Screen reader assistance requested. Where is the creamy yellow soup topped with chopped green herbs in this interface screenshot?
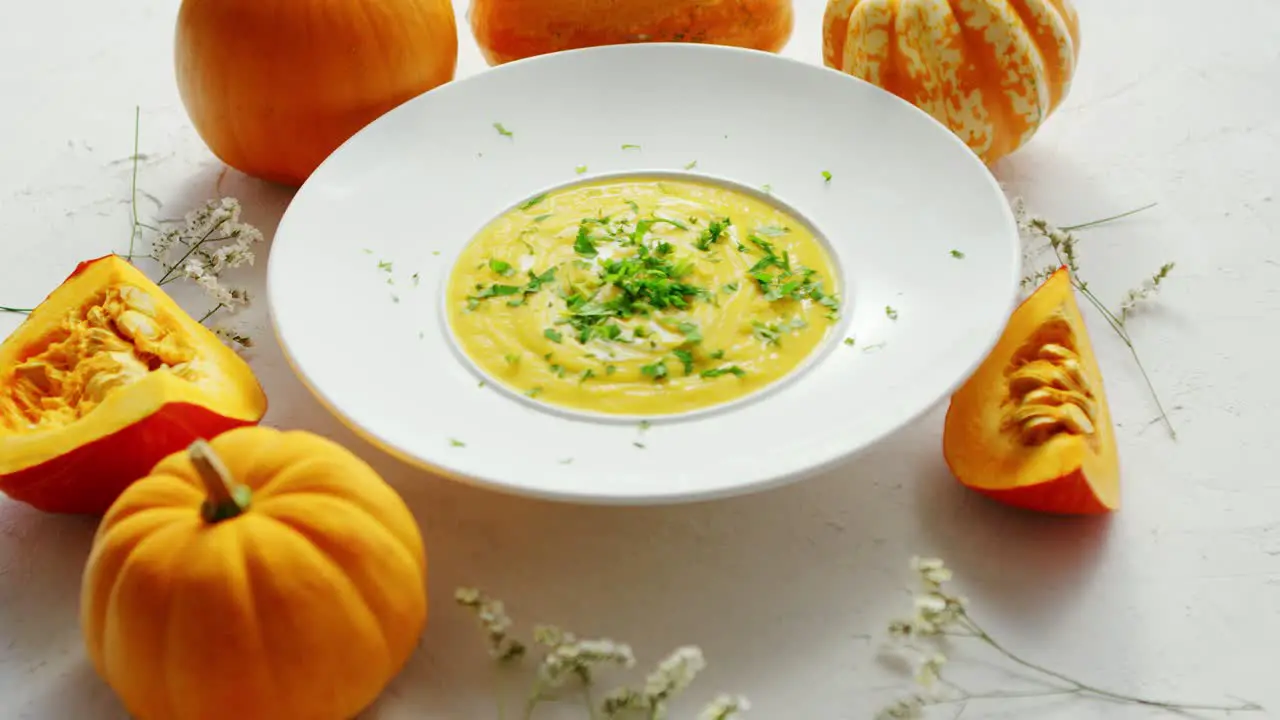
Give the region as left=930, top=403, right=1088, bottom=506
left=447, top=177, right=840, bottom=416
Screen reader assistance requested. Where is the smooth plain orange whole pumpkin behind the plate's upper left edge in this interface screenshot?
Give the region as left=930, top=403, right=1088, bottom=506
left=174, top=0, right=458, bottom=186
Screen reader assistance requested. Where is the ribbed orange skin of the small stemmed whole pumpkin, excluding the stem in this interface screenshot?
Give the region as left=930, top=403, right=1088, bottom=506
left=81, top=427, right=426, bottom=720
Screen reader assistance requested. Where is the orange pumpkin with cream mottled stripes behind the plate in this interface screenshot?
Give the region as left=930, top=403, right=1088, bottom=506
left=822, top=0, right=1080, bottom=164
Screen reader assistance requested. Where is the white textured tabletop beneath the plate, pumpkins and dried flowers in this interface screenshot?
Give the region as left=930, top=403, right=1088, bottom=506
left=0, top=0, right=1280, bottom=720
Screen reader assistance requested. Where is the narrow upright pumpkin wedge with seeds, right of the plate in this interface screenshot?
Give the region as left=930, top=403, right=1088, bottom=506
left=942, top=268, right=1120, bottom=515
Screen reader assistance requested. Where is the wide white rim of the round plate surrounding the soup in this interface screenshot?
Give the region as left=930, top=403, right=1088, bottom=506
left=268, top=45, right=1020, bottom=503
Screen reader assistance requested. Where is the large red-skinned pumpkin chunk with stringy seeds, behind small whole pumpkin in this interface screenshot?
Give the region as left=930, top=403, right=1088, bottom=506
left=0, top=255, right=266, bottom=515
